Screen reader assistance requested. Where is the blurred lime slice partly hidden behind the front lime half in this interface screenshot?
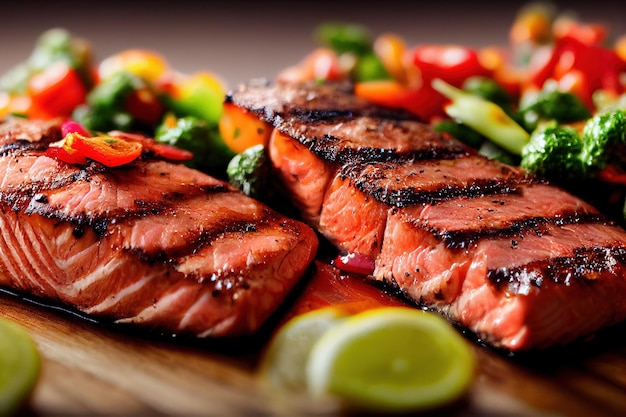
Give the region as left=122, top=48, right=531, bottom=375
left=259, top=307, right=347, bottom=392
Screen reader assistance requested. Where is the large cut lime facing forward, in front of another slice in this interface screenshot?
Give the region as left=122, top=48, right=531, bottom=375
left=306, top=307, right=475, bottom=412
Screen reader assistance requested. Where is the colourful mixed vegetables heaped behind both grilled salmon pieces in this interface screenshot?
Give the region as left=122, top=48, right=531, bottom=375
left=0, top=3, right=626, bottom=221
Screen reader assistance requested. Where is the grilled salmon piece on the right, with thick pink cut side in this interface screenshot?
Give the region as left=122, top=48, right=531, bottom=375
left=227, top=79, right=626, bottom=351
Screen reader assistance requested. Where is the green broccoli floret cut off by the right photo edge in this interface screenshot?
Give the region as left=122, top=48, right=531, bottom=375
left=580, top=109, right=626, bottom=170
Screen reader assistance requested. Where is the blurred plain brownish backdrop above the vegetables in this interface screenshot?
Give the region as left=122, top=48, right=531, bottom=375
left=0, top=0, right=626, bottom=86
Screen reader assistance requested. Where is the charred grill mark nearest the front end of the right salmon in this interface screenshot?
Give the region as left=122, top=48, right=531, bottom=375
left=487, top=247, right=626, bottom=290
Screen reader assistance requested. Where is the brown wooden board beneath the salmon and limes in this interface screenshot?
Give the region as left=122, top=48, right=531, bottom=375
left=0, top=264, right=626, bottom=417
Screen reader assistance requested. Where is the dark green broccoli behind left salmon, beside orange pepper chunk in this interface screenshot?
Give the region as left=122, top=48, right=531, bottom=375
left=154, top=116, right=235, bottom=176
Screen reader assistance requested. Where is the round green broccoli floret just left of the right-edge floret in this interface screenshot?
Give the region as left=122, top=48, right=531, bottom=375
left=520, top=123, right=584, bottom=180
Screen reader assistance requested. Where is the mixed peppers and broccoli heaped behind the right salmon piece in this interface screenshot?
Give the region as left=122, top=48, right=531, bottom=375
left=278, top=3, right=626, bottom=223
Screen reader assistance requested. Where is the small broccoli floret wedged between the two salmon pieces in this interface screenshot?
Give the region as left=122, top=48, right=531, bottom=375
left=226, top=145, right=268, bottom=198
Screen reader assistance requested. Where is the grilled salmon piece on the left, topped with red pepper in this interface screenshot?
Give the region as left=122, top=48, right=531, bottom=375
left=0, top=118, right=318, bottom=338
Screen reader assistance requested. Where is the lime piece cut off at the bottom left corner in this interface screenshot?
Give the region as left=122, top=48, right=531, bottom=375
left=0, top=317, right=41, bottom=416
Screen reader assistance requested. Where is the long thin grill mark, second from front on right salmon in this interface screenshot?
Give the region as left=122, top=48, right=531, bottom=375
left=436, top=213, right=607, bottom=249
